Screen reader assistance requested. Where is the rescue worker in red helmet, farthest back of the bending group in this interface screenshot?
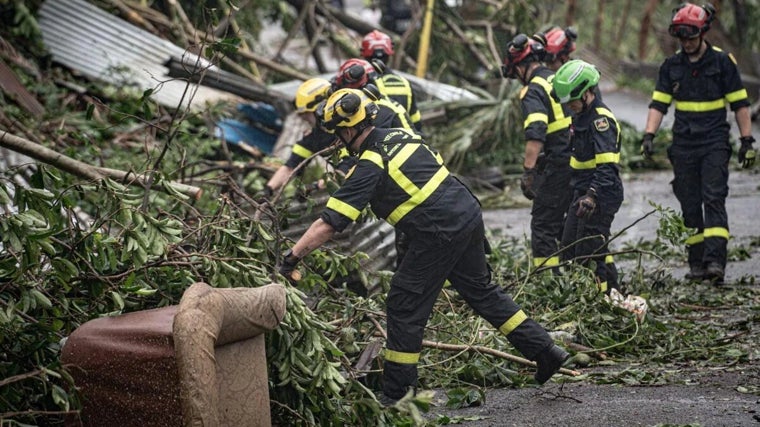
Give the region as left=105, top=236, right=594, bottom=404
left=361, top=30, right=422, bottom=131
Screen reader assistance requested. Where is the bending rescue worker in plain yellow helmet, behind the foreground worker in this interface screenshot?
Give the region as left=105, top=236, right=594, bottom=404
left=263, top=78, right=356, bottom=198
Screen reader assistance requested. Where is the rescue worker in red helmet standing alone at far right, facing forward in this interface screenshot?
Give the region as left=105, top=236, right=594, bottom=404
left=641, top=3, right=756, bottom=284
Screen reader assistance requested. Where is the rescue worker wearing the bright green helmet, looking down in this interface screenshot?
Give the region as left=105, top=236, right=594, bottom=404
left=552, top=59, right=623, bottom=294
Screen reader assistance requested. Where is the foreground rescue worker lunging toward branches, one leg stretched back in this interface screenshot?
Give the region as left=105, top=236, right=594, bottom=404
left=279, top=89, right=568, bottom=404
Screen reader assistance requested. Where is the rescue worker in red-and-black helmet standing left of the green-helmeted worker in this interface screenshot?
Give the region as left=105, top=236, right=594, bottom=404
left=502, top=34, right=572, bottom=274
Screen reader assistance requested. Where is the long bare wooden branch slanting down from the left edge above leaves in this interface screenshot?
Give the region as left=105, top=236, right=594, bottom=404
left=0, top=132, right=203, bottom=199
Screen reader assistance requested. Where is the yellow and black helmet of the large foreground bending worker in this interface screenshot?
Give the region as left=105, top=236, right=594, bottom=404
left=321, top=88, right=379, bottom=131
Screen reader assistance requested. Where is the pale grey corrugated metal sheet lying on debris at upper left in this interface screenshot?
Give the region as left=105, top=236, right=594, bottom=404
left=39, top=0, right=240, bottom=107
